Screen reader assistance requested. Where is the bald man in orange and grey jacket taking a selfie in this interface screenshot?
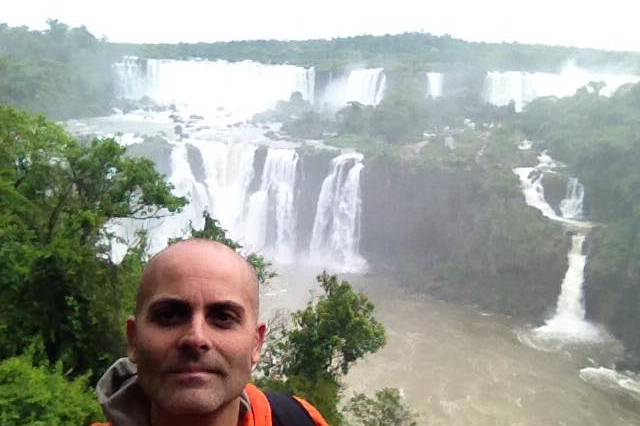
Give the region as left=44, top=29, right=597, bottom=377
left=97, top=240, right=327, bottom=426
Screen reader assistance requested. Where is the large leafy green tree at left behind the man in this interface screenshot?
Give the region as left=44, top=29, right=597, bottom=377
left=0, top=106, right=185, bottom=380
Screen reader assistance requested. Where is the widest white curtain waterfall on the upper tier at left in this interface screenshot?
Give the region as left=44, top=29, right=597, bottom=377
left=114, top=58, right=315, bottom=120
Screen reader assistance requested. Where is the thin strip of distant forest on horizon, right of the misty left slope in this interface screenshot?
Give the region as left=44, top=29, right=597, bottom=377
left=114, top=33, right=640, bottom=72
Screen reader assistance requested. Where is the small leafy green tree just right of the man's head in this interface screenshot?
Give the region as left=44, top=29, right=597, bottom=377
left=260, top=272, right=386, bottom=424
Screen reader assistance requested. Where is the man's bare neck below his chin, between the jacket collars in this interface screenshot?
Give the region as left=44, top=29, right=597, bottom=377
left=151, top=398, right=240, bottom=426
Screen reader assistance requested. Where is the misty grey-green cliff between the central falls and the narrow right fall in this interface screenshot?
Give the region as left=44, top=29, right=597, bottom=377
left=361, top=161, right=568, bottom=322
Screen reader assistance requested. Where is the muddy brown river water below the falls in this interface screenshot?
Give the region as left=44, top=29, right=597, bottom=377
left=263, top=274, right=640, bottom=426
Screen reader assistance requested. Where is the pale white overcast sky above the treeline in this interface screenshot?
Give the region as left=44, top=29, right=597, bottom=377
left=5, top=0, right=640, bottom=51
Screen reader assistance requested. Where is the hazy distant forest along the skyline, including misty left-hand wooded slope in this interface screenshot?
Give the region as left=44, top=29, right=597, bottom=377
left=0, top=20, right=640, bottom=119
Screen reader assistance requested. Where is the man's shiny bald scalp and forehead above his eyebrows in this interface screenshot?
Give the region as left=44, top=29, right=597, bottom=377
left=136, top=239, right=259, bottom=318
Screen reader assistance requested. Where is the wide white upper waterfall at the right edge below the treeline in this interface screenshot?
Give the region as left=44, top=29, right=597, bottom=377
left=482, top=64, right=640, bottom=111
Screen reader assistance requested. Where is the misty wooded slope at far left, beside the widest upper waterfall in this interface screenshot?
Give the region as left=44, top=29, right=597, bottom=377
left=0, top=20, right=115, bottom=119
